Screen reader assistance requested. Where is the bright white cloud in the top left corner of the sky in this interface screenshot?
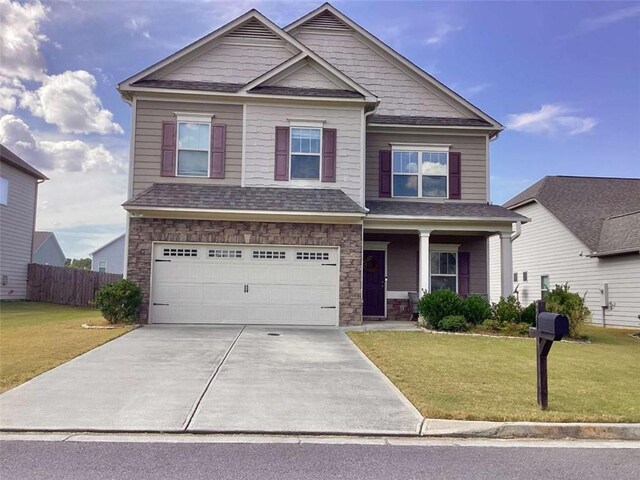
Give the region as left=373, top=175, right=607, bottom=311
left=0, top=0, right=49, bottom=80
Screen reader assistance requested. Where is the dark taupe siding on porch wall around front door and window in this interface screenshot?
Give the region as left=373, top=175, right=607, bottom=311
left=364, top=232, right=488, bottom=295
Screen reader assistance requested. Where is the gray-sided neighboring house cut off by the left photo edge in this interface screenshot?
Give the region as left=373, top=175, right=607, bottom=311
left=0, top=145, right=47, bottom=300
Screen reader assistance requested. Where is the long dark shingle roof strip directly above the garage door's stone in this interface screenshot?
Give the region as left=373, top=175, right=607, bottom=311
left=123, top=183, right=364, bottom=213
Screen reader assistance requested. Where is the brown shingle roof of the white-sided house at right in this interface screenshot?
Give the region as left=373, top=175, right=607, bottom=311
left=504, top=176, right=640, bottom=252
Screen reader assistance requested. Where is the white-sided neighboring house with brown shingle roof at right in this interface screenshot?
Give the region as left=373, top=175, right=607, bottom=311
left=491, top=176, right=640, bottom=327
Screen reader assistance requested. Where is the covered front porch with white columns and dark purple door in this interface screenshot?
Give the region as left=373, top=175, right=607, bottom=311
left=362, top=219, right=524, bottom=321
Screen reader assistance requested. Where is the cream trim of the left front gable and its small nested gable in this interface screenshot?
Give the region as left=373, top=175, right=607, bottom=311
left=118, top=9, right=377, bottom=102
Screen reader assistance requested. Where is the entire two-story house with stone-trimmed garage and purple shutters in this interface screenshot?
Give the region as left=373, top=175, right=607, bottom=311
left=118, top=4, right=527, bottom=325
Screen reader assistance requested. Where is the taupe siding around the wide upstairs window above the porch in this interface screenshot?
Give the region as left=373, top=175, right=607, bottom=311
left=365, top=130, right=487, bottom=203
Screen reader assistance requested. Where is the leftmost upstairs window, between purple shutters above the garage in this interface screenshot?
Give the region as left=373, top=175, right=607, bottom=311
left=176, top=121, right=211, bottom=177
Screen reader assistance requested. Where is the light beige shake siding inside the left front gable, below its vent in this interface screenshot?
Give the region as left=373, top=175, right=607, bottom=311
left=152, top=39, right=294, bottom=83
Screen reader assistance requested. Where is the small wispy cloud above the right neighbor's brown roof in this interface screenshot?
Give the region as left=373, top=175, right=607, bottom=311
left=506, top=104, right=598, bottom=135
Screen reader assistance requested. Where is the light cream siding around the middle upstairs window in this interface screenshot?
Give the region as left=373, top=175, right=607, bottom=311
left=245, top=105, right=362, bottom=203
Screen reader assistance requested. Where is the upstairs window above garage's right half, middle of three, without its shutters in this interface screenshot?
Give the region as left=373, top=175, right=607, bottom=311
left=289, top=127, right=322, bottom=180
